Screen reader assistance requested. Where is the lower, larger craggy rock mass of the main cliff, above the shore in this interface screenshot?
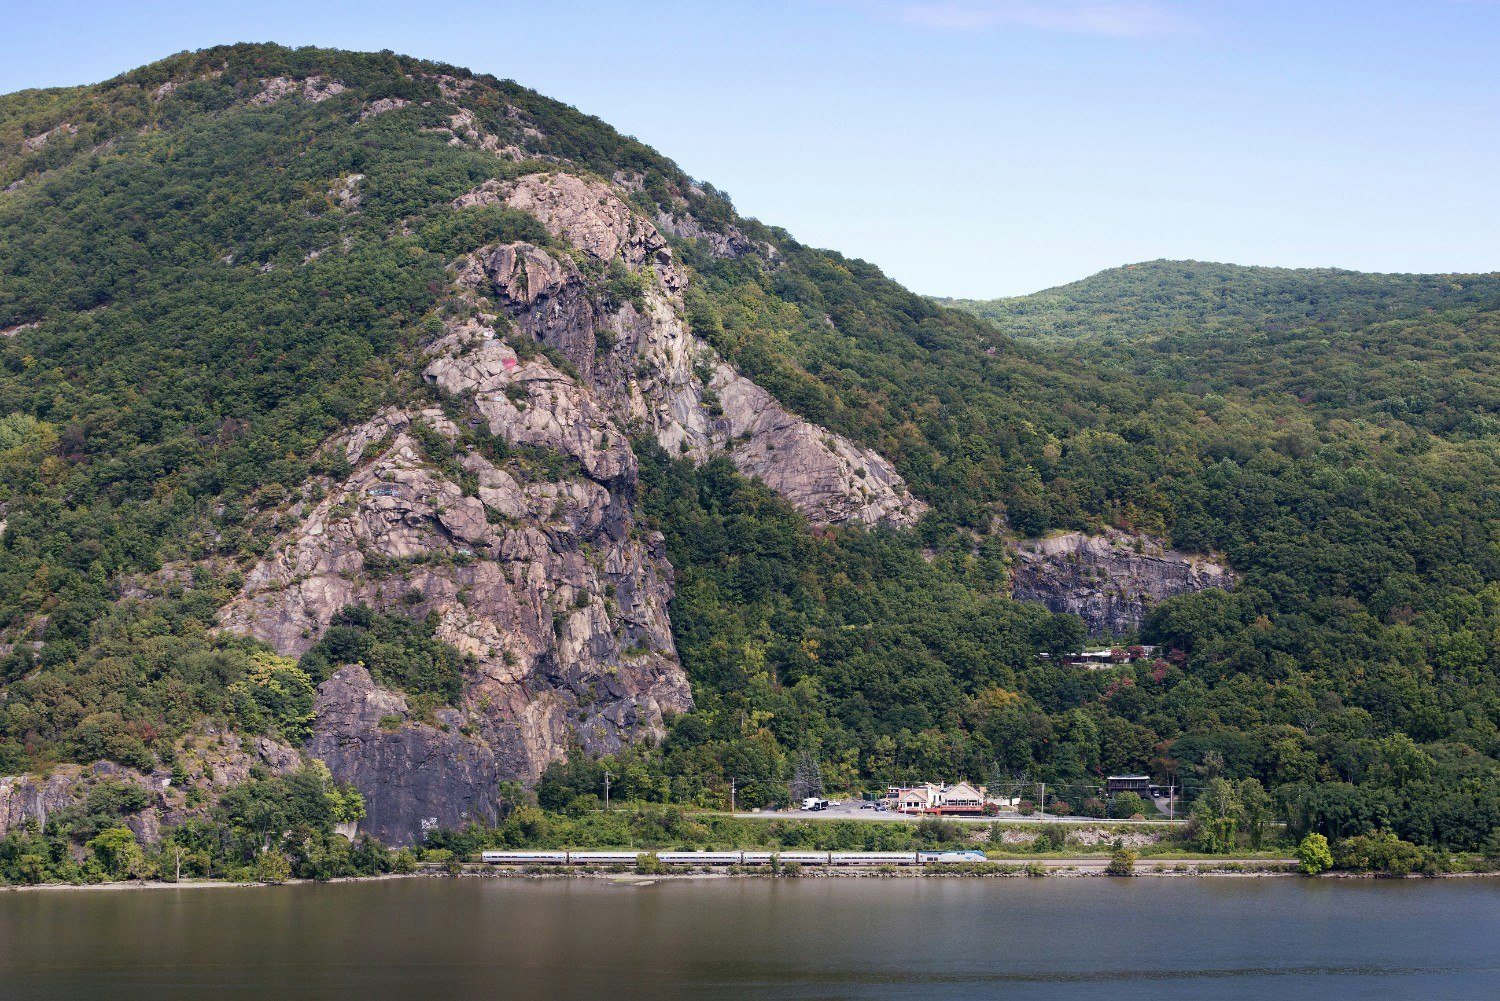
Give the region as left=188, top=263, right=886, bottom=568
left=222, top=402, right=692, bottom=843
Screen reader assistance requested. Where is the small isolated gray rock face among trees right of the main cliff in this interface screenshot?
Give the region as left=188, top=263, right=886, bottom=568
left=1011, top=531, right=1235, bottom=638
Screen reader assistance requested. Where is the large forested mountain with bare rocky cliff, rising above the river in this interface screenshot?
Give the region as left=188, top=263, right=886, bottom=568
left=0, top=45, right=1500, bottom=878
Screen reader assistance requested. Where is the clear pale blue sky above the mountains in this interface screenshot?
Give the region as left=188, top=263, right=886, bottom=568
left=0, top=0, right=1500, bottom=297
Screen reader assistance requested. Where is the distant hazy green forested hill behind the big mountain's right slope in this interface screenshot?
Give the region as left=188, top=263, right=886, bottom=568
left=950, top=261, right=1500, bottom=437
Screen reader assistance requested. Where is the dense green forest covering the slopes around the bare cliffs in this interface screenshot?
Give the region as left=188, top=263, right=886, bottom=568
left=0, top=45, right=1500, bottom=882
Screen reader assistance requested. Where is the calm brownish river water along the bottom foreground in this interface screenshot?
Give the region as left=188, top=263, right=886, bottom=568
left=0, top=876, right=1500, bottom=1001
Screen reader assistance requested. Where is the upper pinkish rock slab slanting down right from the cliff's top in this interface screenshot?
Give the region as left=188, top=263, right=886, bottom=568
left=444, top=174, right=926, bottom=525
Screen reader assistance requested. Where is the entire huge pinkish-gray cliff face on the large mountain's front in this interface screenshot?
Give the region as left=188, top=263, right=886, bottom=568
left=207, top=108, right=926, bottom=843
